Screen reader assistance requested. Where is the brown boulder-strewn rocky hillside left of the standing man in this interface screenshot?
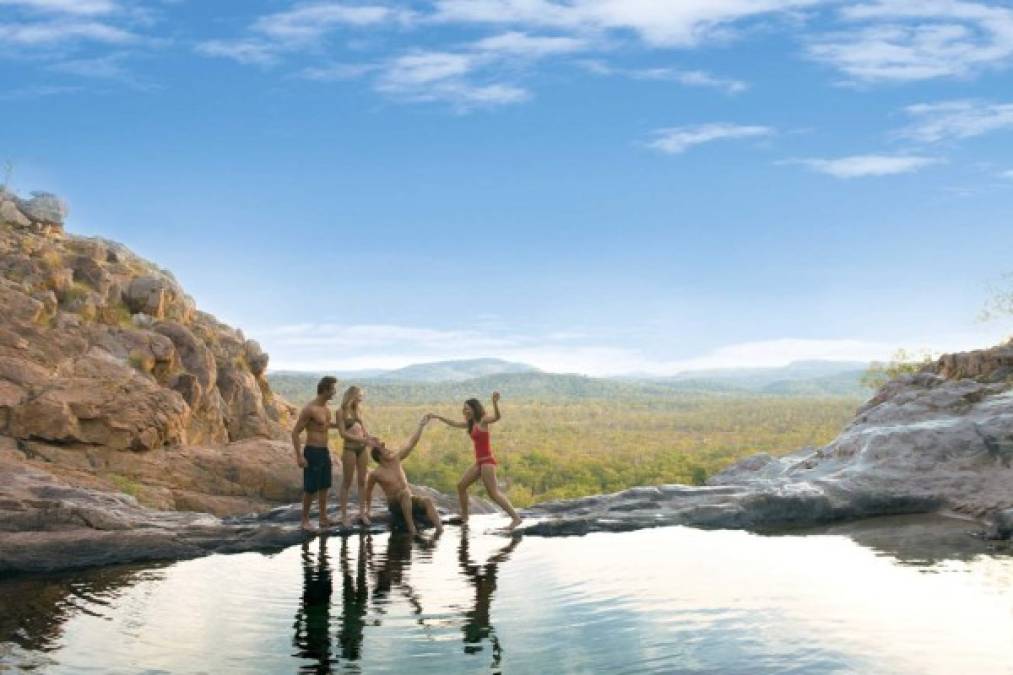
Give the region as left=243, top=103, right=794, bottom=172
left=0, top=191, right=299, bottom=514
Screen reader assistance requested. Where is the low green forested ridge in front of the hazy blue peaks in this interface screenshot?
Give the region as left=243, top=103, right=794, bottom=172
left=268, top=364, right=869, bottom=403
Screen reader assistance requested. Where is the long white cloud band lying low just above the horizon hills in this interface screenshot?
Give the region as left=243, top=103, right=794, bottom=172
left=254, top=323, right=1005, bottom=376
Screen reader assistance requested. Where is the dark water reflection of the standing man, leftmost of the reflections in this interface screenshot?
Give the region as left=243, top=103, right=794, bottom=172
left=293, top=537, right=335, bottom=673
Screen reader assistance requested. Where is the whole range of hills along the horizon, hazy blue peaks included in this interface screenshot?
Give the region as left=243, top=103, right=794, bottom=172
left=268, top=359, right=871, bottom=402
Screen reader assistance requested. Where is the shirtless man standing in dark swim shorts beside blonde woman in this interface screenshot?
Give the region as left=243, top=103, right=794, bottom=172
left=292, top=375, right=337, bottom=532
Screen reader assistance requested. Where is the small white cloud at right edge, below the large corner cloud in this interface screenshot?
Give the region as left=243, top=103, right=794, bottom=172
left=901, top=100, right=1013, bottom=143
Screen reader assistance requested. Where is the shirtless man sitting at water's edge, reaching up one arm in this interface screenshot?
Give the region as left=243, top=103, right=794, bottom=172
left=362, top=415, right=443, bottom=534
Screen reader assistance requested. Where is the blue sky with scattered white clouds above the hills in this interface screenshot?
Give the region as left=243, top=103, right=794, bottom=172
left=0, top=0, right=1013, bottom=375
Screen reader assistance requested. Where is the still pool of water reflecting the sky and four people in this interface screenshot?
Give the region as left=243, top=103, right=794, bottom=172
left=0, top=517, right=1013, bottom=674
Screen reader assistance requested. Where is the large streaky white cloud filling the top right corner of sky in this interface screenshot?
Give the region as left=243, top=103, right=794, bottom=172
left=808, top=0, right=1013, bottom=82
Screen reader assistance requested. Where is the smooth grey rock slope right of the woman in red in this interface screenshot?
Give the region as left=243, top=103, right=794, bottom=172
left=525, top=342, right=1013, bottom=539
